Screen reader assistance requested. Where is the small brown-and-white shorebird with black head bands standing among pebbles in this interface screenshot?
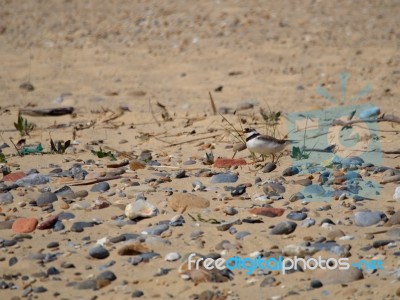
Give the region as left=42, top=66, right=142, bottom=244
left=243, top=128, right=292, bottom=162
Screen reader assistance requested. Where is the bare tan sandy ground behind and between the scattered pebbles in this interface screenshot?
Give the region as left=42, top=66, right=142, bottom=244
left=0, top=0, right=400, bottom=299
